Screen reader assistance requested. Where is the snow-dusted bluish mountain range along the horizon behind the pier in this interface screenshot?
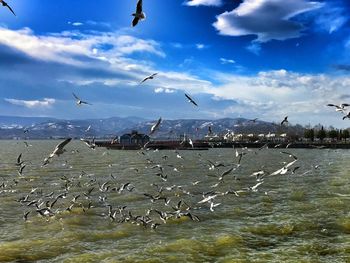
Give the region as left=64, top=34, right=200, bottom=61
left=0, top=116, right=304, bottom=139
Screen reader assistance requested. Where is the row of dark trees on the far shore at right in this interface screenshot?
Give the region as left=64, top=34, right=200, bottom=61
left=304, top=127, right=350, bottom=141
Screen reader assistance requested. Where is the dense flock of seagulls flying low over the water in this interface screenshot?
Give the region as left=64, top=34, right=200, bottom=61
left=0, top=136, right=318, bottom=229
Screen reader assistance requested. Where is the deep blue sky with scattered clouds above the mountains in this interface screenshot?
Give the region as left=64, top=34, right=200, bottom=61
left=0, top=0, right=350, bottom=128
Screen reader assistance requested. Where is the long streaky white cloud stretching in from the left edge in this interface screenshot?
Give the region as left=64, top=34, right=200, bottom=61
left=0, top=27, right=165, bottom=66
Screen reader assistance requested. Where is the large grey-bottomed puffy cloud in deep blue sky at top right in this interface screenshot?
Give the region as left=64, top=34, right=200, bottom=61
left=213, top=0, right=322, bottom=42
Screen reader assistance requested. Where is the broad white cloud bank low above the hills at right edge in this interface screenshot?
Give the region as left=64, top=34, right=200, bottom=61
left=198, top=69, right=350, bottom=125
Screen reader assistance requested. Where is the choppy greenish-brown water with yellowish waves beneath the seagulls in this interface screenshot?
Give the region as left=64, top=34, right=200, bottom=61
left=0, top=141, right=350, bottom=262
